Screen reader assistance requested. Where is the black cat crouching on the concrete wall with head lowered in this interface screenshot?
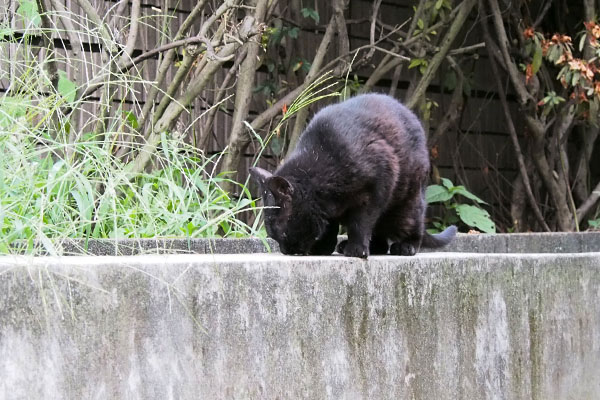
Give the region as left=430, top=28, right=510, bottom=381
left=250, top=94, right=456, bottom=258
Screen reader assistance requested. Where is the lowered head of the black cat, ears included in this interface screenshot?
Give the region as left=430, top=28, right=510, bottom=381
left=250, top=167, right=327, bottom=254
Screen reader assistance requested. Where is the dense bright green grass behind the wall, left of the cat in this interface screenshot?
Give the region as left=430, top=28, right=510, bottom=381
left=0, top=126, right=264, bottom=254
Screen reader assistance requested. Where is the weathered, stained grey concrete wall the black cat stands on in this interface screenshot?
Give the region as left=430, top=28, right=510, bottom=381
left=0, top=253, right=600, bottom=400
